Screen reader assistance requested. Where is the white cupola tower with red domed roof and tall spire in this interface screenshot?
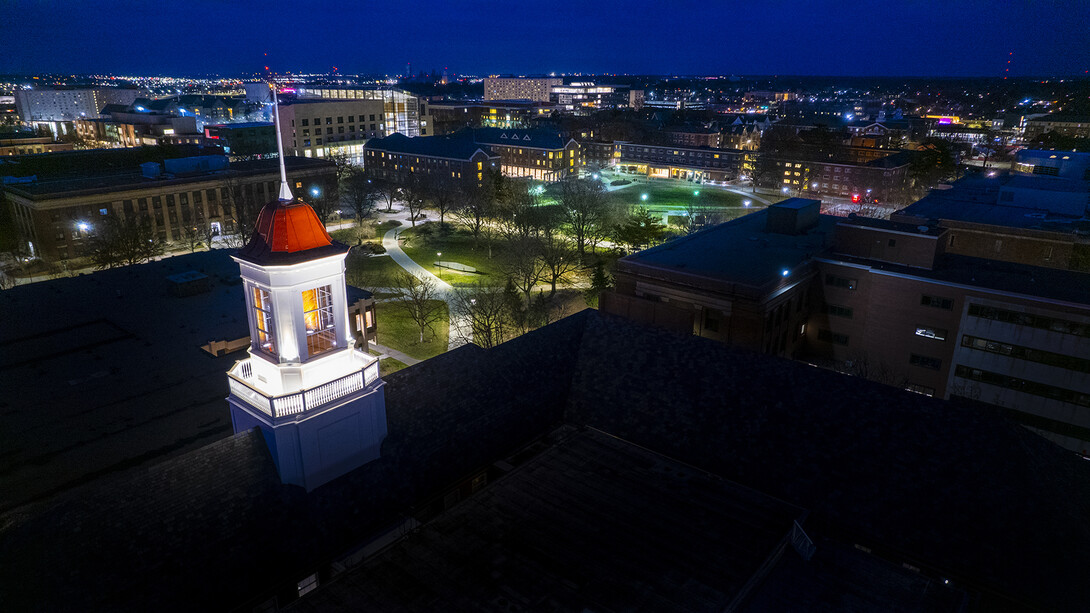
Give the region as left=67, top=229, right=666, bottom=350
left=227, top=86, right=386, bottom=491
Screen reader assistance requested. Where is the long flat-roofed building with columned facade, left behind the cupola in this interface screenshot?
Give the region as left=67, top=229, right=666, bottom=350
left=3, top=147, right=336, bottom=260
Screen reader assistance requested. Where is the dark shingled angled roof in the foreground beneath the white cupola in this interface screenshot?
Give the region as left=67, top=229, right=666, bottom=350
left=0, top=311, right=1090, bottom=611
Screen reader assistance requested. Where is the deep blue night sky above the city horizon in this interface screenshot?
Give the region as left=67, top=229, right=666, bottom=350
left=0, top=0, right=1090, bottom=76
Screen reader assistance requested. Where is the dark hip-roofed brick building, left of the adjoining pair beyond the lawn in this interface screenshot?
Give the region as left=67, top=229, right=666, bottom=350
left=364, top=134, right=500, bottom=187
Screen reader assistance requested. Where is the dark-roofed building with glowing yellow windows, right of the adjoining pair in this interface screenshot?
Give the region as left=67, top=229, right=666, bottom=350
left=470, top=128, right=583, bottom=181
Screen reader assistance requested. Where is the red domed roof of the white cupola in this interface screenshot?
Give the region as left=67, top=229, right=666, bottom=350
left=238, top=199, right=348, bottom=264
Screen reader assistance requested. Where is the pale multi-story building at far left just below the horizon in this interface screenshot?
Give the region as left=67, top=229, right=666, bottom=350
left=15, top=87, right=142, bottom=124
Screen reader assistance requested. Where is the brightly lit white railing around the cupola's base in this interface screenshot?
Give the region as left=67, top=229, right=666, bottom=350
left=227, top=353, right=378, bottom=418
